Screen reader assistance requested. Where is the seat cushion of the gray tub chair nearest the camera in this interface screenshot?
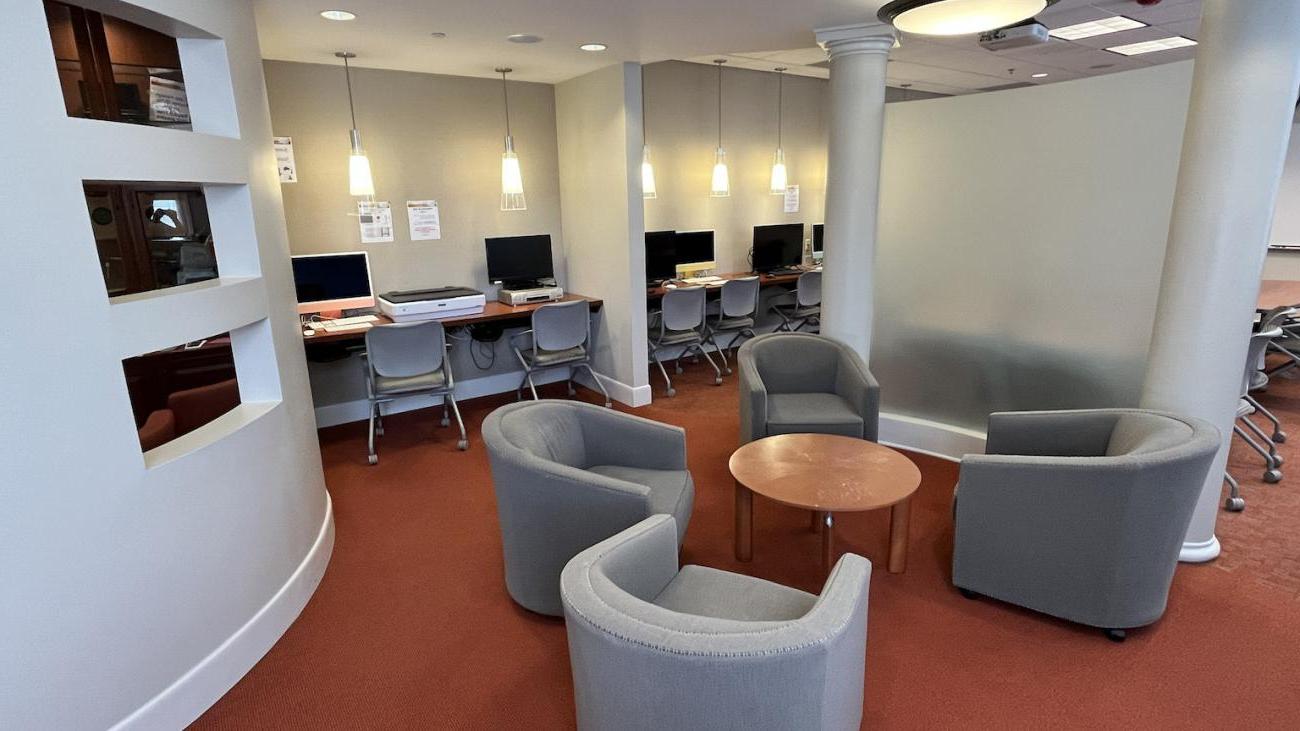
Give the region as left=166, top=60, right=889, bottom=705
left=653, top=566, right=816, bottom=622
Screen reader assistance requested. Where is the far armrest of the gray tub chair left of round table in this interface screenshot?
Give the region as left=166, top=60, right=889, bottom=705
left=581, top=408, right=686, bottom=470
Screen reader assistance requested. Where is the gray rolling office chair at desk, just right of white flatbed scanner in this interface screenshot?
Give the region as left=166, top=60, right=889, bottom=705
left=510, top=300, right=612, bottom=407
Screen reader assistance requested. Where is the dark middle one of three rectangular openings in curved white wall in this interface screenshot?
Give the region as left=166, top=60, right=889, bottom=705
left=85, top=181, right=217, bottom=297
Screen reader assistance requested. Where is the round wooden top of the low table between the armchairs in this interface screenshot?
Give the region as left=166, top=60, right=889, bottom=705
left=729, top=434, right=920, bottom=512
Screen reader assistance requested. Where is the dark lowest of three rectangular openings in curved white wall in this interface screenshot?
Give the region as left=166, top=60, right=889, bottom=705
left=122, top=333, right=241, bottom=451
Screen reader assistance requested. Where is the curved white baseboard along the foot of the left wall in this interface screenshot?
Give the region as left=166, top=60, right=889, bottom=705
left=112, top=493, right=334, bottom=731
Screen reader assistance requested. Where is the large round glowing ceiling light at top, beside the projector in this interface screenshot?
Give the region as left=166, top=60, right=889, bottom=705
left=876, top=0, right=1057, bottom=35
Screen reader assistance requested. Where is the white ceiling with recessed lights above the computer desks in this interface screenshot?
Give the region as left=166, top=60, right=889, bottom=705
left=255, top=0, right=1201, bottom=94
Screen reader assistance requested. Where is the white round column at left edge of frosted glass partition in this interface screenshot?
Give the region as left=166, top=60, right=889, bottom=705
left=816, top=23, right=894, bottom=359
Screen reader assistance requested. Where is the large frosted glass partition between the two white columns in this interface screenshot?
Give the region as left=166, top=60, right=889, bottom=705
left=871, top=62, right=1197, bottom=431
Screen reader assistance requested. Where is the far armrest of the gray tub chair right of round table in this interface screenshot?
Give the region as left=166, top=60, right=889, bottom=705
left=984, top=408, right=1122, bottom=457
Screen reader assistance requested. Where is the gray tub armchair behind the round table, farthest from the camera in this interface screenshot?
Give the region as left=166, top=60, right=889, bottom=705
left=736, top=333, right=880, bottom=444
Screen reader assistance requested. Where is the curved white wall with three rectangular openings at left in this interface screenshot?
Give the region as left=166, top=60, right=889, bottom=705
left=0, top=0, right=333, bottom=728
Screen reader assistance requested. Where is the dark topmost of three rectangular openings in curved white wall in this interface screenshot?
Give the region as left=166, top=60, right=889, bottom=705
left=46, top=0, right=191, bottom=129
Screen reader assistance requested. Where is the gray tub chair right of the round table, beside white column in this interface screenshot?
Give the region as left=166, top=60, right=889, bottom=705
left=953, top=408, right=1219, bottom=641
